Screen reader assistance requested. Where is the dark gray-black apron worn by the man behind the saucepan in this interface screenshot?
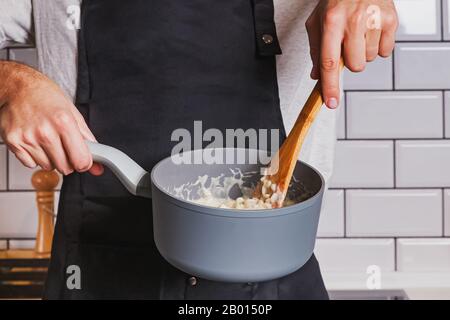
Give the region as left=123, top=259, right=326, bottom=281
left=45, top=0, right=327, bottom=299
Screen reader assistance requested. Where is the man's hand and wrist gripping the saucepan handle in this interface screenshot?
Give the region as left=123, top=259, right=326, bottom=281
left=0, top=61, right=103, bottom=175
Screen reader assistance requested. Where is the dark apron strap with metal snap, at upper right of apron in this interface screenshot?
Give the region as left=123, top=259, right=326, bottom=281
left=252, top=0, right=281, bottom=56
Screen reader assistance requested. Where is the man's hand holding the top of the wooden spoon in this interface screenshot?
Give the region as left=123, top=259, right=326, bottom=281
left=306, top=0, right=398, bottom=109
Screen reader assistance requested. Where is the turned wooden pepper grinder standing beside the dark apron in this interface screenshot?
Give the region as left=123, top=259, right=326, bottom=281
left=31, top=170, right=59, bottom=254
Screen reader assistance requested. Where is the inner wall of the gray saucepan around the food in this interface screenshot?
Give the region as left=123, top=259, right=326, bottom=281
left=152, top=148, right=323, bottom=202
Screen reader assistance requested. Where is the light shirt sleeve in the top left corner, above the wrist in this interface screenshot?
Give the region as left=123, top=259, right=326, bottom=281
left=0, top=0, right=33, bottom=49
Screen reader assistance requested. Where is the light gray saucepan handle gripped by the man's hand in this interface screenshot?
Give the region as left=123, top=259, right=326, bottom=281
left=86, top=141, right=151, bottom=198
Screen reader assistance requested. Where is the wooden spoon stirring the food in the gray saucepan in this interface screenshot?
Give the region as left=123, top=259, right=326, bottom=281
left=254, top=58, right=344, bottom=208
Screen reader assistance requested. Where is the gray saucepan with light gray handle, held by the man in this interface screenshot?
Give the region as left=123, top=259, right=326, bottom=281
left=88, top=142, right=324, bottom=282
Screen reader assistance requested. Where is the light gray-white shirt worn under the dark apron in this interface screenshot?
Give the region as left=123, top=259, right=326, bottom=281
left=0, top=0, right=339, bottom=180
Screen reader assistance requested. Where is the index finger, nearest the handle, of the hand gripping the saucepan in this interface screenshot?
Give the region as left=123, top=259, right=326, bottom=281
left=60, top=116, right=92, bottom=172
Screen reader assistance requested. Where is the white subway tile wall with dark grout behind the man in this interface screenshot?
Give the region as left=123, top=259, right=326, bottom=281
left=0, top=0, right=450, bottom=272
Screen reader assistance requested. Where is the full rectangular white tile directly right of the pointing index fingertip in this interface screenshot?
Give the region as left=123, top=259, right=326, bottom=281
left=347, top=91, right=443, bottom=139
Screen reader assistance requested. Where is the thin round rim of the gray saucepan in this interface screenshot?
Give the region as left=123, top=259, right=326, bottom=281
left=150, top=148, right=325, bottom=219
